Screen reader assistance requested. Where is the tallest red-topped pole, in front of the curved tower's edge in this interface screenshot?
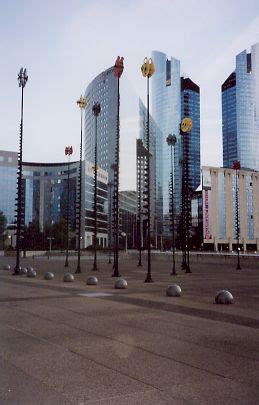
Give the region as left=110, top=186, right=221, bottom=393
left=112, top=56, right=124, bottom=277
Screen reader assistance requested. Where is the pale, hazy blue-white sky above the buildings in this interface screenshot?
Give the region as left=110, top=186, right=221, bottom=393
left=0, top=0, right=259, bottom=190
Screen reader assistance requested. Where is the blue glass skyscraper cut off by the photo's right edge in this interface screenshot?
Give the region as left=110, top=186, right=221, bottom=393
left=221, top=43, right=259, bottom=170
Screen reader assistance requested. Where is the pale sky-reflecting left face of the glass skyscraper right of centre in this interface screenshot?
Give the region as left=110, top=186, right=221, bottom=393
left=151, top=51, right=181, bottom=234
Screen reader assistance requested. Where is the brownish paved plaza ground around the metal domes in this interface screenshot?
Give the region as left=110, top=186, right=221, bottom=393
left=0, top=257, right=259, bottom=405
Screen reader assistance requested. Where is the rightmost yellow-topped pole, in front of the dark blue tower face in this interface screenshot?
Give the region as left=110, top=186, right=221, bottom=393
left=180, top=117, right=192, bottom=273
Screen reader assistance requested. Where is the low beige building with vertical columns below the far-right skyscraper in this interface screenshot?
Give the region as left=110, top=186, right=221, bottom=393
left=202, top=166, right=259, bottom=251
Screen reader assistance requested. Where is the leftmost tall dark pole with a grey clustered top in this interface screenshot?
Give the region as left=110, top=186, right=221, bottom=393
left=13, top=68, right=28, bottom=276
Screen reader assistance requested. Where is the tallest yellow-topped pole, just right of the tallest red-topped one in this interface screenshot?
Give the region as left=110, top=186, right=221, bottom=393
left=141, top=58, right=155, bottom=283
